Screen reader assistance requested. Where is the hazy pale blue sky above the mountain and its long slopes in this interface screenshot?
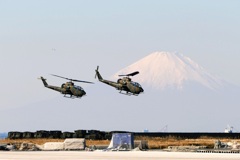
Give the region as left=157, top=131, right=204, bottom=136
left=0, top=0, right=240, bottom=131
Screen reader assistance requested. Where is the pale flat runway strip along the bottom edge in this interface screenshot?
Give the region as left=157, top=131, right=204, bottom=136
left=0, top=151, right=240, bottom=160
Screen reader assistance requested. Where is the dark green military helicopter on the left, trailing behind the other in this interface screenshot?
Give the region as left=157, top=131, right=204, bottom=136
left=39, top=74, right=93, bottom=98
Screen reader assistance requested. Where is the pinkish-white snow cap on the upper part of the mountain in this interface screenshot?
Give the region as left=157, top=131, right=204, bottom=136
left=113, top=52, right=224, bottom=90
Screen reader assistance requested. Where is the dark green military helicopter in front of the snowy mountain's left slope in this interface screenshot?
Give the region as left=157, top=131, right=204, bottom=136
left=95, top=66, right=144, bottom=96
